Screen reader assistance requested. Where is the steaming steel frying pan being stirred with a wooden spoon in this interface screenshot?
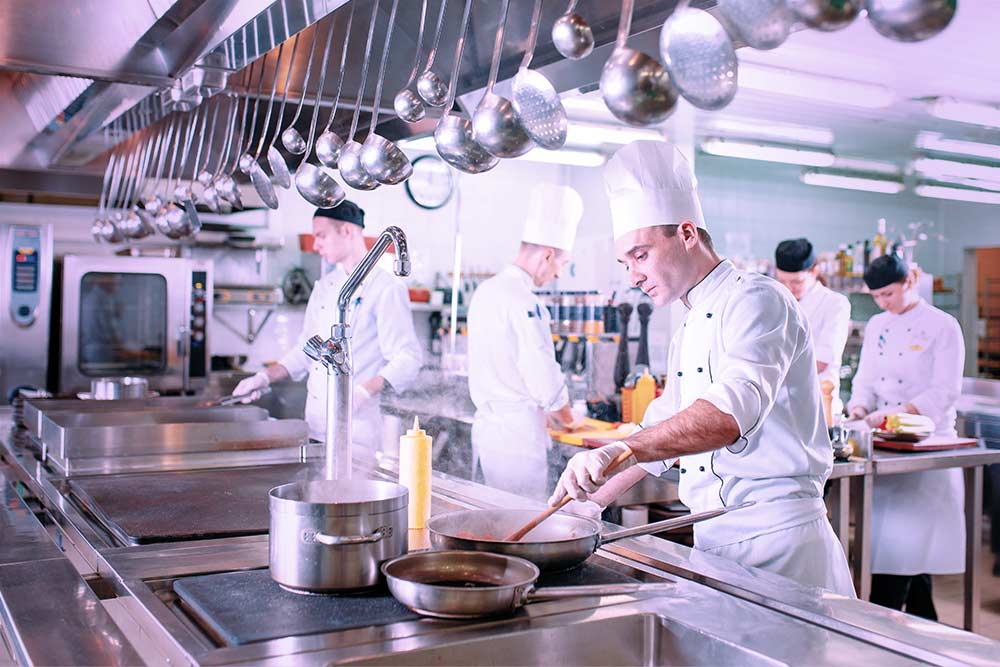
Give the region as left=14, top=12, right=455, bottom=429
left=427, top=501, right=754, bottom=570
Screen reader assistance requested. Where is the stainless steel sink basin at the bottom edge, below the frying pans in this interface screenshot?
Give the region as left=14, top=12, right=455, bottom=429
left=351, top=613, right=787, bottom=666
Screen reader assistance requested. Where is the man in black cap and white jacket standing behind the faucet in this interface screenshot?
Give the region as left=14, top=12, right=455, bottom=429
left=233, top=200, right=422, bottom=463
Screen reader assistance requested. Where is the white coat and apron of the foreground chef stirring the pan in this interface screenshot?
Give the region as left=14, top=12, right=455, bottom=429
left=641, top=260, right=854, bottom=596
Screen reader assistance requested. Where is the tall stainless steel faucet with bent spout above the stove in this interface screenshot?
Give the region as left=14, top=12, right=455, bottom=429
left=303, top=227, right=410, bottom=479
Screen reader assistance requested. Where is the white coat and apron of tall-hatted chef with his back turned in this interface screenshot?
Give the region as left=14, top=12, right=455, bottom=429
left=468, top=265, right=569, bottom=500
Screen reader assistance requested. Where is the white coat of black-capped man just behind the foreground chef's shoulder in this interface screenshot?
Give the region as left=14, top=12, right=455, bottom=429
left=799, top=281, right=851, bottom=414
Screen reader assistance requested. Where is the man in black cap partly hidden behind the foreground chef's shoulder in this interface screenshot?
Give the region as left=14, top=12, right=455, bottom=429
left=774, top=238, right=851, bottom=415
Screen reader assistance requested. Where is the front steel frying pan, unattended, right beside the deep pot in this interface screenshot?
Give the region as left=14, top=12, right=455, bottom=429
left=382, top=551, right=671, bottom=619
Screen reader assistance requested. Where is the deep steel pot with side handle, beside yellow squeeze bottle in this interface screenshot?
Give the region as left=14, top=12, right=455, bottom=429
left=269, top=480, right=409, bottom=593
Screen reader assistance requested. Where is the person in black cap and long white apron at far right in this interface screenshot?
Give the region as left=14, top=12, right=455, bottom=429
left=847, top=254, right=965, bottom=620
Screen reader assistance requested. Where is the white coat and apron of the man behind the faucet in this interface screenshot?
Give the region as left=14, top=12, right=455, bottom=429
left=280, top=265, right=422, bottom=461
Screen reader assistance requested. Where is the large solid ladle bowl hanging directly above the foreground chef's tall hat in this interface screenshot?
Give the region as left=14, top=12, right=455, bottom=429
left=601, top=48, right=677, bottom=126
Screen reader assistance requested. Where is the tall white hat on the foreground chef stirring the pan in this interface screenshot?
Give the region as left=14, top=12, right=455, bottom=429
left=604, top=141, right=705, bottom=239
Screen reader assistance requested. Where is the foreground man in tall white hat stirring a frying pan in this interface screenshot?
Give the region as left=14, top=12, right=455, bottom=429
left=550, top=141, right=854, bottom=596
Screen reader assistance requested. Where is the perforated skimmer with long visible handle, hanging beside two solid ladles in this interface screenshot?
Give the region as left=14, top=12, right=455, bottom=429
left=511, top=0, right=569, bottom=150
